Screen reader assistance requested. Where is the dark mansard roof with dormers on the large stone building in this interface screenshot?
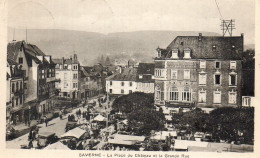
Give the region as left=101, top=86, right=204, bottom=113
left=157, top=36, right=243, bottom=60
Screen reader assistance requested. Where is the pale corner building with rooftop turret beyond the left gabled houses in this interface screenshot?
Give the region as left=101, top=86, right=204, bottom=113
left=53, top=54, right=81, bottom=99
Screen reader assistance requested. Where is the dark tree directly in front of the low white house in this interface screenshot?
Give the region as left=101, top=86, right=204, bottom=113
left=112, top=92, right=155, bottom=113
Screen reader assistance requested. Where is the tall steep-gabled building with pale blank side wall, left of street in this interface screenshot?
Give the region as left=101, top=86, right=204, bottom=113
left=7, top=41, right=57, bottom=122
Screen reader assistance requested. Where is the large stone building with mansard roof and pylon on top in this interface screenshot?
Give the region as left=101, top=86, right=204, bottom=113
left=154, top=34, right=243, bottom=107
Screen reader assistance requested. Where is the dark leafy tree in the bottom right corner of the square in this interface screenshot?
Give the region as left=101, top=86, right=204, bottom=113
left=210, top=107, right=254, bottom=144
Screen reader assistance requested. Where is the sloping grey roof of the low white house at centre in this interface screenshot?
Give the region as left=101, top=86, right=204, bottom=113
left=106, top=68, right=137, bottom=81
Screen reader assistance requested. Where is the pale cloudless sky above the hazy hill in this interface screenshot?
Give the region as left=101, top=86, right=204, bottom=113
left=7, top=0, right=255, bottom=44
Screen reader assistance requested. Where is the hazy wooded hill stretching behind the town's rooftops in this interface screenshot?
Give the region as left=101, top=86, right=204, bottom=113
left=8, top=28, right=219, bottom=65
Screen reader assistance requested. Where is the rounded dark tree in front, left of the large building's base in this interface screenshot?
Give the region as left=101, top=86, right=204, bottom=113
left=127, top=107, right=165, bottom=135
